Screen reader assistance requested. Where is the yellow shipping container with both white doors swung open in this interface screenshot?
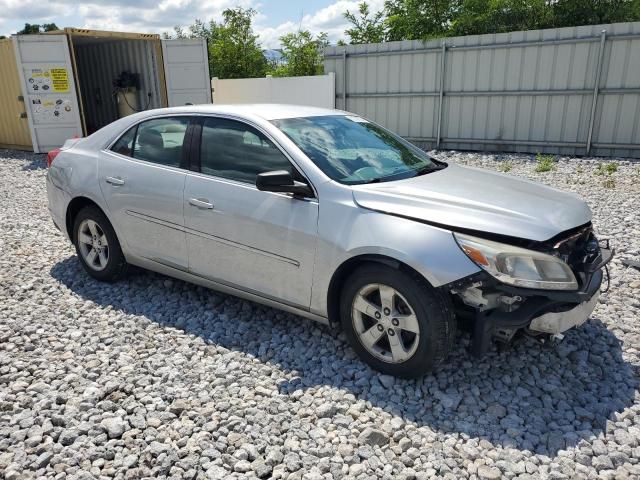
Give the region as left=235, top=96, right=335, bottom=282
left=0, top=28, right=211, bottom=152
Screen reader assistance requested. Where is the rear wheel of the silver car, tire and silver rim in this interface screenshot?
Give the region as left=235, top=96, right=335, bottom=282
left=73, top=206, right=127, bottom=282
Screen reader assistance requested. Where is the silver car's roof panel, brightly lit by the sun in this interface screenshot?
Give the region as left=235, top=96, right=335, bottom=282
left=148, top=103, right=348, bottom=120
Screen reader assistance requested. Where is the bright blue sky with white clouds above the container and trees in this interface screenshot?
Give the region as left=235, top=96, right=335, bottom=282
left=0, top=0, right=384, bottom=48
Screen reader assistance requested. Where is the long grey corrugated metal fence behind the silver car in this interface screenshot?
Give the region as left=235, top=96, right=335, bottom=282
left=324, top=22, right=640, bottom=158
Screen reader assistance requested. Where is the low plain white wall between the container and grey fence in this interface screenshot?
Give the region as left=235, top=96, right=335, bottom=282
left=211, top=73, right=336, bottom=108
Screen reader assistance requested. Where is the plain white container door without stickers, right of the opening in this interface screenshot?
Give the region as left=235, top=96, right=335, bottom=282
left=162, top=38, right=211, bottom=107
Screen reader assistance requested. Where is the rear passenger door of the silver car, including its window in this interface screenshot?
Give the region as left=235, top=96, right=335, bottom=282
left=98, top=117, right=189, bottom=271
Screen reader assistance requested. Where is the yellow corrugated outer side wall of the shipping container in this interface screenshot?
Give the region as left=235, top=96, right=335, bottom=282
left=0, top=38, right=31, bottom=150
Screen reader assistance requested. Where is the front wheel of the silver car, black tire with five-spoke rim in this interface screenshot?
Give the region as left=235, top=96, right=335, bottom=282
left=340, top=263, right=455, bottom=378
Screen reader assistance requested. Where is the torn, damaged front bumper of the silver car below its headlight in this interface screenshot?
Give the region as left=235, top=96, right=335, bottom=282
left=450, top=248, right=614, bottom=356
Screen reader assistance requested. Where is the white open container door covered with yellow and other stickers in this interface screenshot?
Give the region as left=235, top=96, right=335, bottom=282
left=13, top=34, right=82, bottom=153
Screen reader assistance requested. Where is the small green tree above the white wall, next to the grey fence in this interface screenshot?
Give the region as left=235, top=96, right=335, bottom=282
left=270, top=30, right=329, bottom=77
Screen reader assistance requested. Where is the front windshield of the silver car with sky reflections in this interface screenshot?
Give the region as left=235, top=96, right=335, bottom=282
left=272, top=115, right=446, bottom=184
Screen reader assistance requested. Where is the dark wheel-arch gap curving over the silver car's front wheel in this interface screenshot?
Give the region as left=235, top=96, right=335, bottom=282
left=327, top=253, right=438, bottom=325
